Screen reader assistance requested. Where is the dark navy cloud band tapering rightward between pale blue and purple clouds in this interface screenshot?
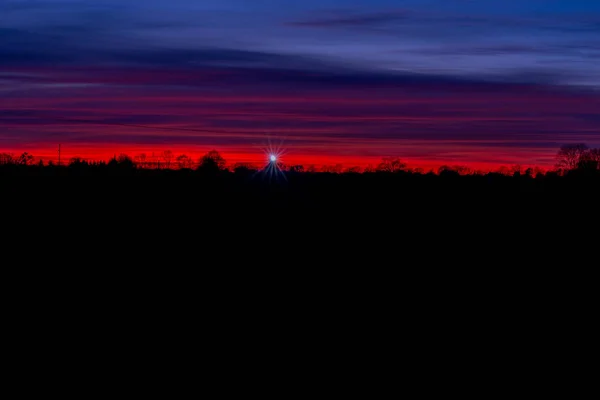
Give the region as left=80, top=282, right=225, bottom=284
left=0, top=22, right=580, bottom=90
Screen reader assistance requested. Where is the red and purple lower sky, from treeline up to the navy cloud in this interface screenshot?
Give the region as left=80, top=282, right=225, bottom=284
left=0, top=67, right=600, bottom=171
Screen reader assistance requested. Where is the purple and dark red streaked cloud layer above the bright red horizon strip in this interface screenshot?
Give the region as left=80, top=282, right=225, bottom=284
left=0, top=67, right=600, bottom=168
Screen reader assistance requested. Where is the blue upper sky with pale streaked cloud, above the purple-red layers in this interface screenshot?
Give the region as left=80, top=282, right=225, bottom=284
left=0, top=0, right=600, bottom=86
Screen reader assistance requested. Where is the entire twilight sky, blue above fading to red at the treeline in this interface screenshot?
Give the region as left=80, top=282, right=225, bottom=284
left=0, top=0, right=600, bottom=169
